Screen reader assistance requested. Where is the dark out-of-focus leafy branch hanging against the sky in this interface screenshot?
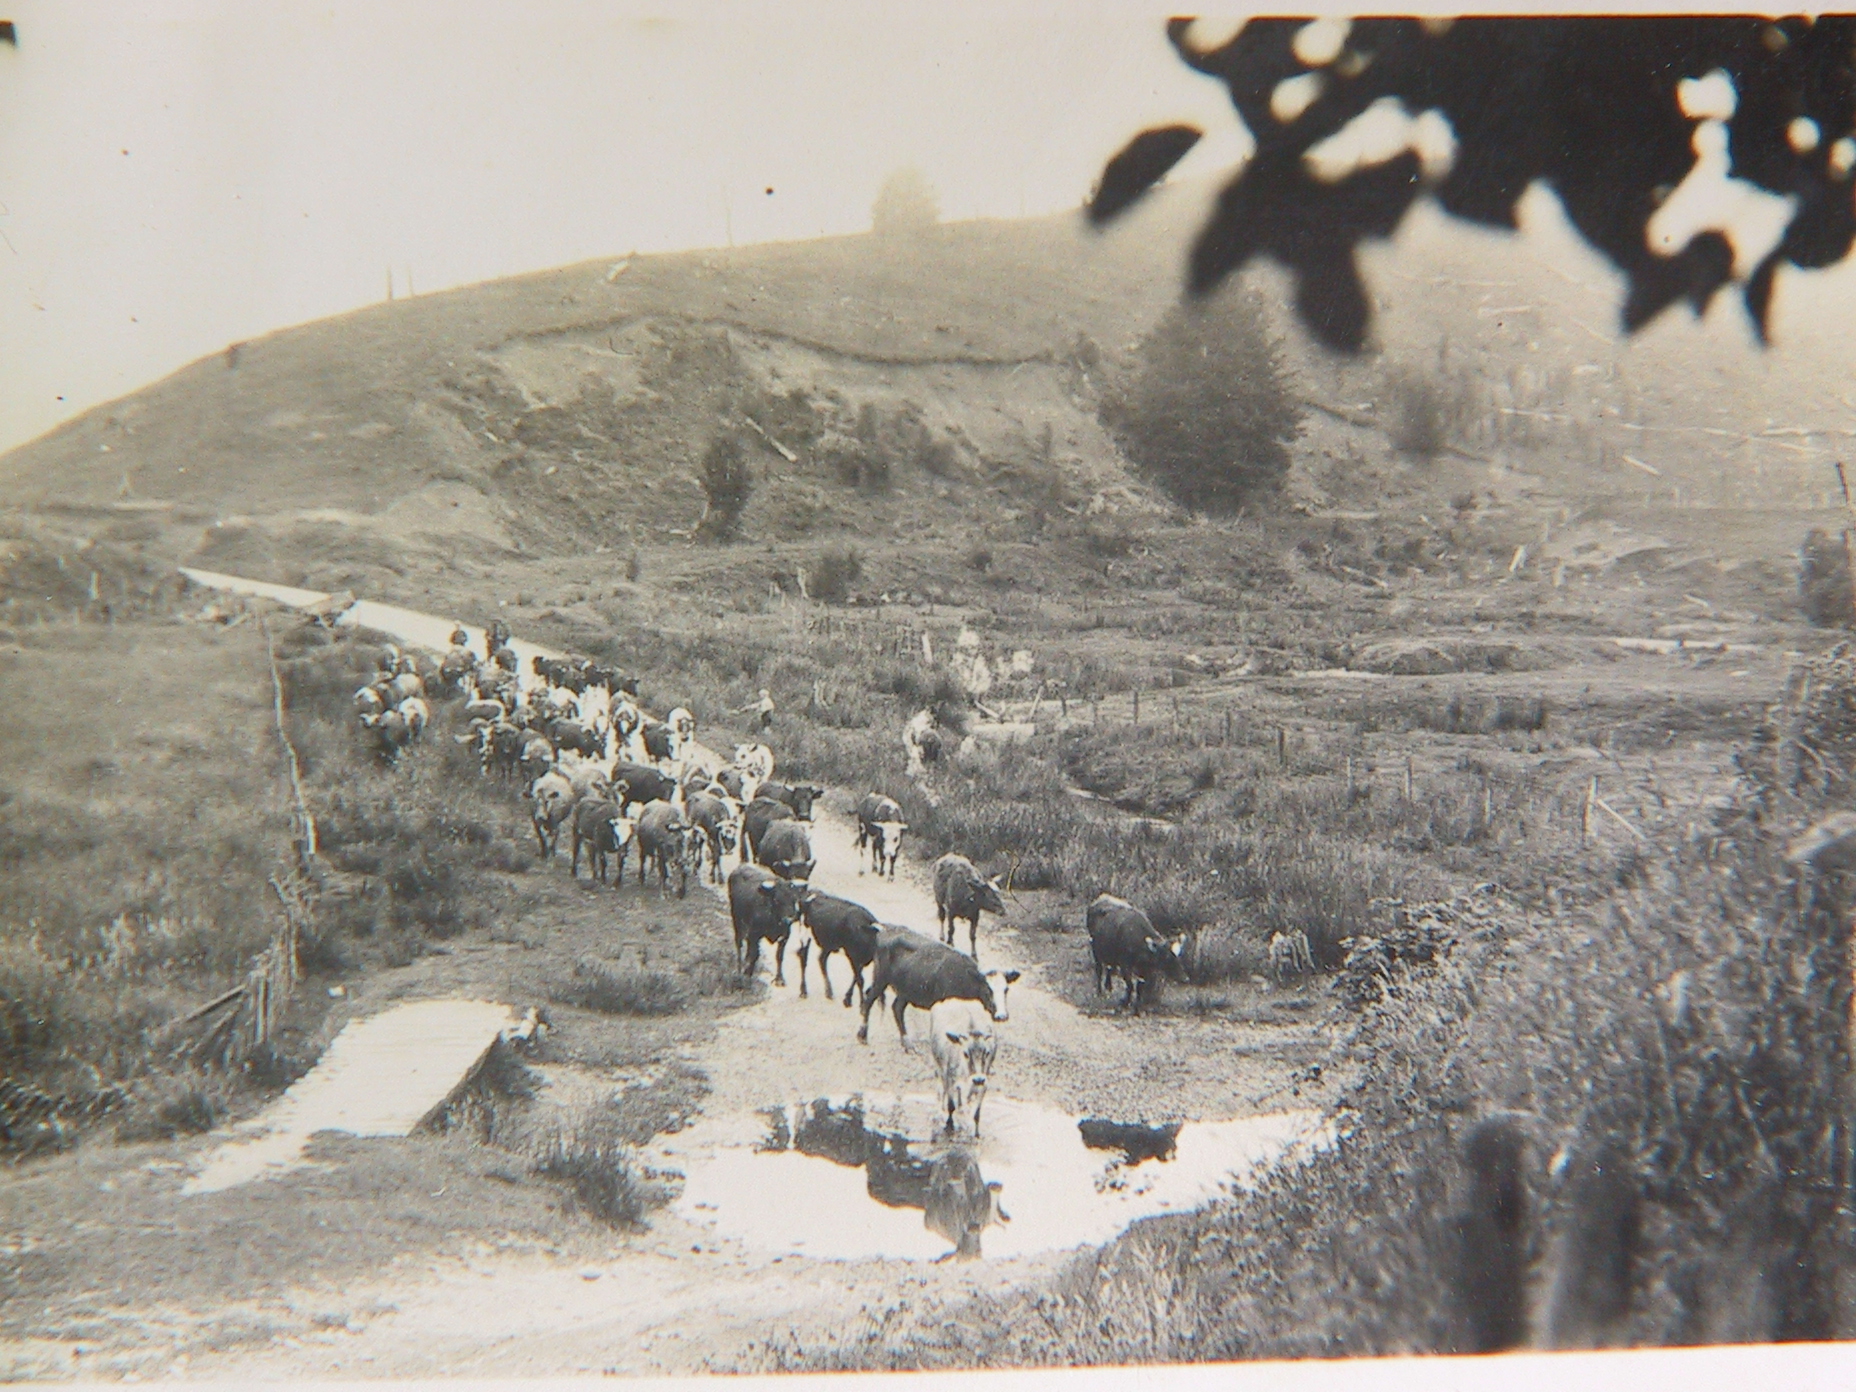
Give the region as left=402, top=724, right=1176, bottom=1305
left=1089, top=15, right=1856, bottom=351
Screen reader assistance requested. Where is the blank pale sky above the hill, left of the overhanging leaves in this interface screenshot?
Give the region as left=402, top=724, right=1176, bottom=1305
left=0, top=0, right=1841, bottom=458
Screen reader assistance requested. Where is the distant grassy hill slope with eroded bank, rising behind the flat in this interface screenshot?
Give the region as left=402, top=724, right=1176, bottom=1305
left=0, top=186, right=1856, bottom=579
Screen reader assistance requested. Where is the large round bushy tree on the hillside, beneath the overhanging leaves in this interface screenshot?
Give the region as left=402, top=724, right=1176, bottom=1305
left=1102, top=286, right=1301, bottom=512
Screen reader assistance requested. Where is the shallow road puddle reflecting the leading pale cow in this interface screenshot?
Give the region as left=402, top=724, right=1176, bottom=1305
left=664, top=1097, right=1321, bottom=1260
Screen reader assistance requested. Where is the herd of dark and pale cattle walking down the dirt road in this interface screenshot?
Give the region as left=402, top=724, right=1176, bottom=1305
left=354, top=624, right=1224, bottom=1136
